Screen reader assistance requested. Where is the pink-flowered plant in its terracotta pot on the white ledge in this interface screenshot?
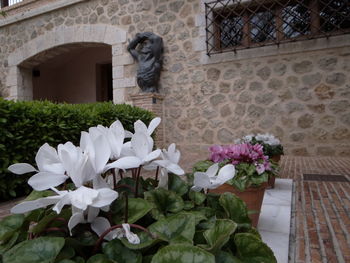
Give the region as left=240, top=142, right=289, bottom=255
left=194, top=142, right=271, bottom=226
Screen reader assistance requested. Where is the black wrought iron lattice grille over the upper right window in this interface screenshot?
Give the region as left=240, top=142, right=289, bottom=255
left=205, top=0, right=350, bottom=56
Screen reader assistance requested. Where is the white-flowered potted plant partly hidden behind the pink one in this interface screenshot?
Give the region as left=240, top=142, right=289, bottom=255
left=238, top=133, right=284, bottom=188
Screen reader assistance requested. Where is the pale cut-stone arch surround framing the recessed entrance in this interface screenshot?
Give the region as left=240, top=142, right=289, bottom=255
left=6, top=24, right=136, bottom=103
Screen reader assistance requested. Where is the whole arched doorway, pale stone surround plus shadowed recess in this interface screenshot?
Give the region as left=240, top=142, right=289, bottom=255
left=5, top=25, right=131, bottom=103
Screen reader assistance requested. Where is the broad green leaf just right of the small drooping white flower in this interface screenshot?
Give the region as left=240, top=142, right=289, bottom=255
left=148, top=213, right=195, bottom=244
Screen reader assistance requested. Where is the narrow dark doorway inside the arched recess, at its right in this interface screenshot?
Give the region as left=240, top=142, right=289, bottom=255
left=96, top=63, right=113, bottom=101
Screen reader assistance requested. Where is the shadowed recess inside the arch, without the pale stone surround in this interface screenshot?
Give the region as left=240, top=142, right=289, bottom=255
left=19, top=43, right=113, bottom=103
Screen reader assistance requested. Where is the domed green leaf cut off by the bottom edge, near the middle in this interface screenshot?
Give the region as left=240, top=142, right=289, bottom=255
left=151, top=244, right=215, bottom=263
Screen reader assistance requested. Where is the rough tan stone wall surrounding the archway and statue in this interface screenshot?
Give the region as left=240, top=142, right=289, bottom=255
left=0, top=0, right=350, bottom=172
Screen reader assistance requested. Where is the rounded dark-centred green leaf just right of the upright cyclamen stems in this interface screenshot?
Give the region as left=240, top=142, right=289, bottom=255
left=145, top=188, right=184, bottom=219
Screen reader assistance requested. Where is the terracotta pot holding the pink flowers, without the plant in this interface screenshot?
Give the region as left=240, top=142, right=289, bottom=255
left=210, top=183, right=267, bottom=227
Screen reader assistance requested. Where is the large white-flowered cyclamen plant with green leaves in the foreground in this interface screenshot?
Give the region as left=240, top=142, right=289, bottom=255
left=0, top=118, right=277, bottom=263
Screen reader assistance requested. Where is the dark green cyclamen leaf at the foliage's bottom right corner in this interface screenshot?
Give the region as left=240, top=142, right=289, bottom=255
left=234, top=233, right=277, bottom=263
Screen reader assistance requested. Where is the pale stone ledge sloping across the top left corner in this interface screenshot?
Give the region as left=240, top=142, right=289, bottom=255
left=0, top=0, right=88, bottom=28
